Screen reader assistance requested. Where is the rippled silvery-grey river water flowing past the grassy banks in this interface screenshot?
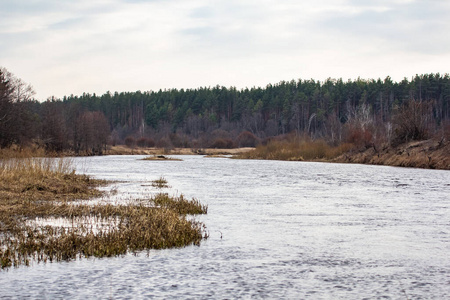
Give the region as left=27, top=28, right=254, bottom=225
left=0, top=156, right=450, bottom=299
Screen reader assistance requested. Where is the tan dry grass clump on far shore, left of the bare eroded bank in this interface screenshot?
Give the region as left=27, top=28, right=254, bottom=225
left=235, top=139, right=352, bottom=161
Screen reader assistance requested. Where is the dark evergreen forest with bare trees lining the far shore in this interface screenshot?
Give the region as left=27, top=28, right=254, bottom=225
left=0, top=68, right=450, bottom=155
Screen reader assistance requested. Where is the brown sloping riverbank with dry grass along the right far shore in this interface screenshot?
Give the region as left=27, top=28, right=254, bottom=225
left=235, top=139, right=450, bottom=170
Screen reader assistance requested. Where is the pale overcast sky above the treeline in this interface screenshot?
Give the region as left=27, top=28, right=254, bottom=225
left=0, top=0, right=450, bottom=101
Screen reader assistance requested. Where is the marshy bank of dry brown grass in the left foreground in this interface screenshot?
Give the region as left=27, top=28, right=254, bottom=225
left=0, top=158, right=207, bottom=269
